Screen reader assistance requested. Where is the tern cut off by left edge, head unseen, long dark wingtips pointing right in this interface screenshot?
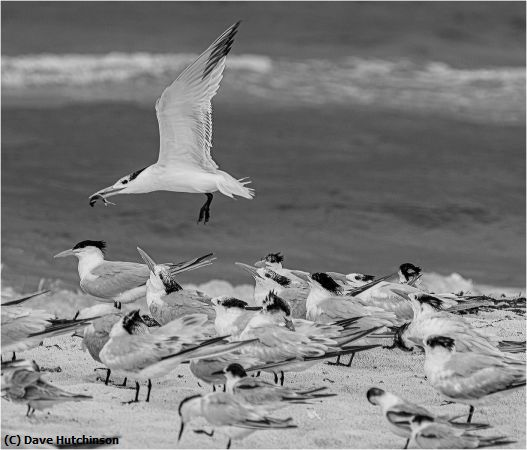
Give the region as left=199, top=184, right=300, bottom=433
left=1, top=302, right=96, bottom=359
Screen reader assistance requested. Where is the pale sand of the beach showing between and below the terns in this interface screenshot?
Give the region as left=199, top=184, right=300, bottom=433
left=2, top=306, right=525, bottom=448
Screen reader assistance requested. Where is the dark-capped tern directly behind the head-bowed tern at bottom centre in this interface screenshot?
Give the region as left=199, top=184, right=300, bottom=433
left=222, top=364, right=336, bottom=409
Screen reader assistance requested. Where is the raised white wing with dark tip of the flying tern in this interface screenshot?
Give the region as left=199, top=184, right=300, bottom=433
left=156, top=22, right=239, bottom=172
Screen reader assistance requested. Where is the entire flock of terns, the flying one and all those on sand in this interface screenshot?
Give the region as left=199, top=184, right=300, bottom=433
left=1, top=22, right=525, bottom=448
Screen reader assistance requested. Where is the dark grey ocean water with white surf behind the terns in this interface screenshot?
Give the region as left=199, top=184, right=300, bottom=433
left=1, top=2, right=525, bottom=298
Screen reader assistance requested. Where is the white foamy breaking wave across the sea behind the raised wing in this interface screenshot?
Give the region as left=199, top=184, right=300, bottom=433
left=2, top=52, right=525, bottom=123
